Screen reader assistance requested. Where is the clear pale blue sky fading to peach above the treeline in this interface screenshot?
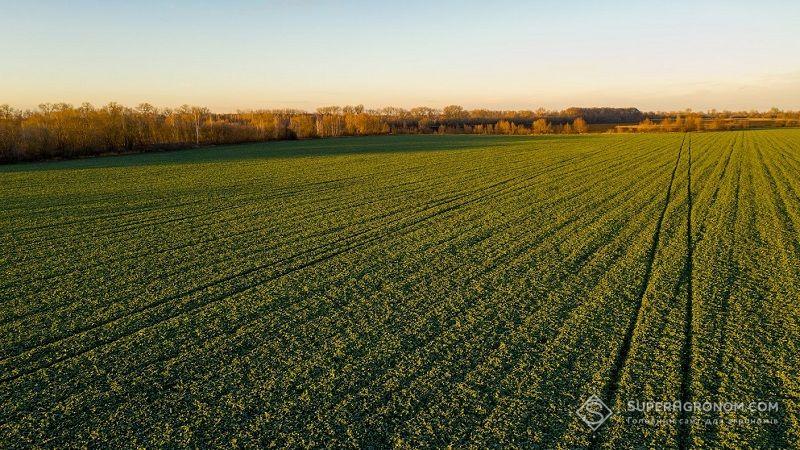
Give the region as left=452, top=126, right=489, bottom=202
left=0, top=0, right=800, bottom=112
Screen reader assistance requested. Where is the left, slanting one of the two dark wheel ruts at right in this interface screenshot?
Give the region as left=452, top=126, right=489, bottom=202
left=589, top=134, right=686, bottom=449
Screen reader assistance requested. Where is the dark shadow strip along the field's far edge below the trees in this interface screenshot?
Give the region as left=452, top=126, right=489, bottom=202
left=0, top=135, right=590, bottom=173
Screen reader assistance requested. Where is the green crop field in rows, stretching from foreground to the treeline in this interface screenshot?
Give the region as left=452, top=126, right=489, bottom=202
left=0, top=130, right=800, bottom=449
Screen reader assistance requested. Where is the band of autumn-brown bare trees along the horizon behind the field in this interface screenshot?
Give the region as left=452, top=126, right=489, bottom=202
left=0, top=103, right=800, bottom=162
